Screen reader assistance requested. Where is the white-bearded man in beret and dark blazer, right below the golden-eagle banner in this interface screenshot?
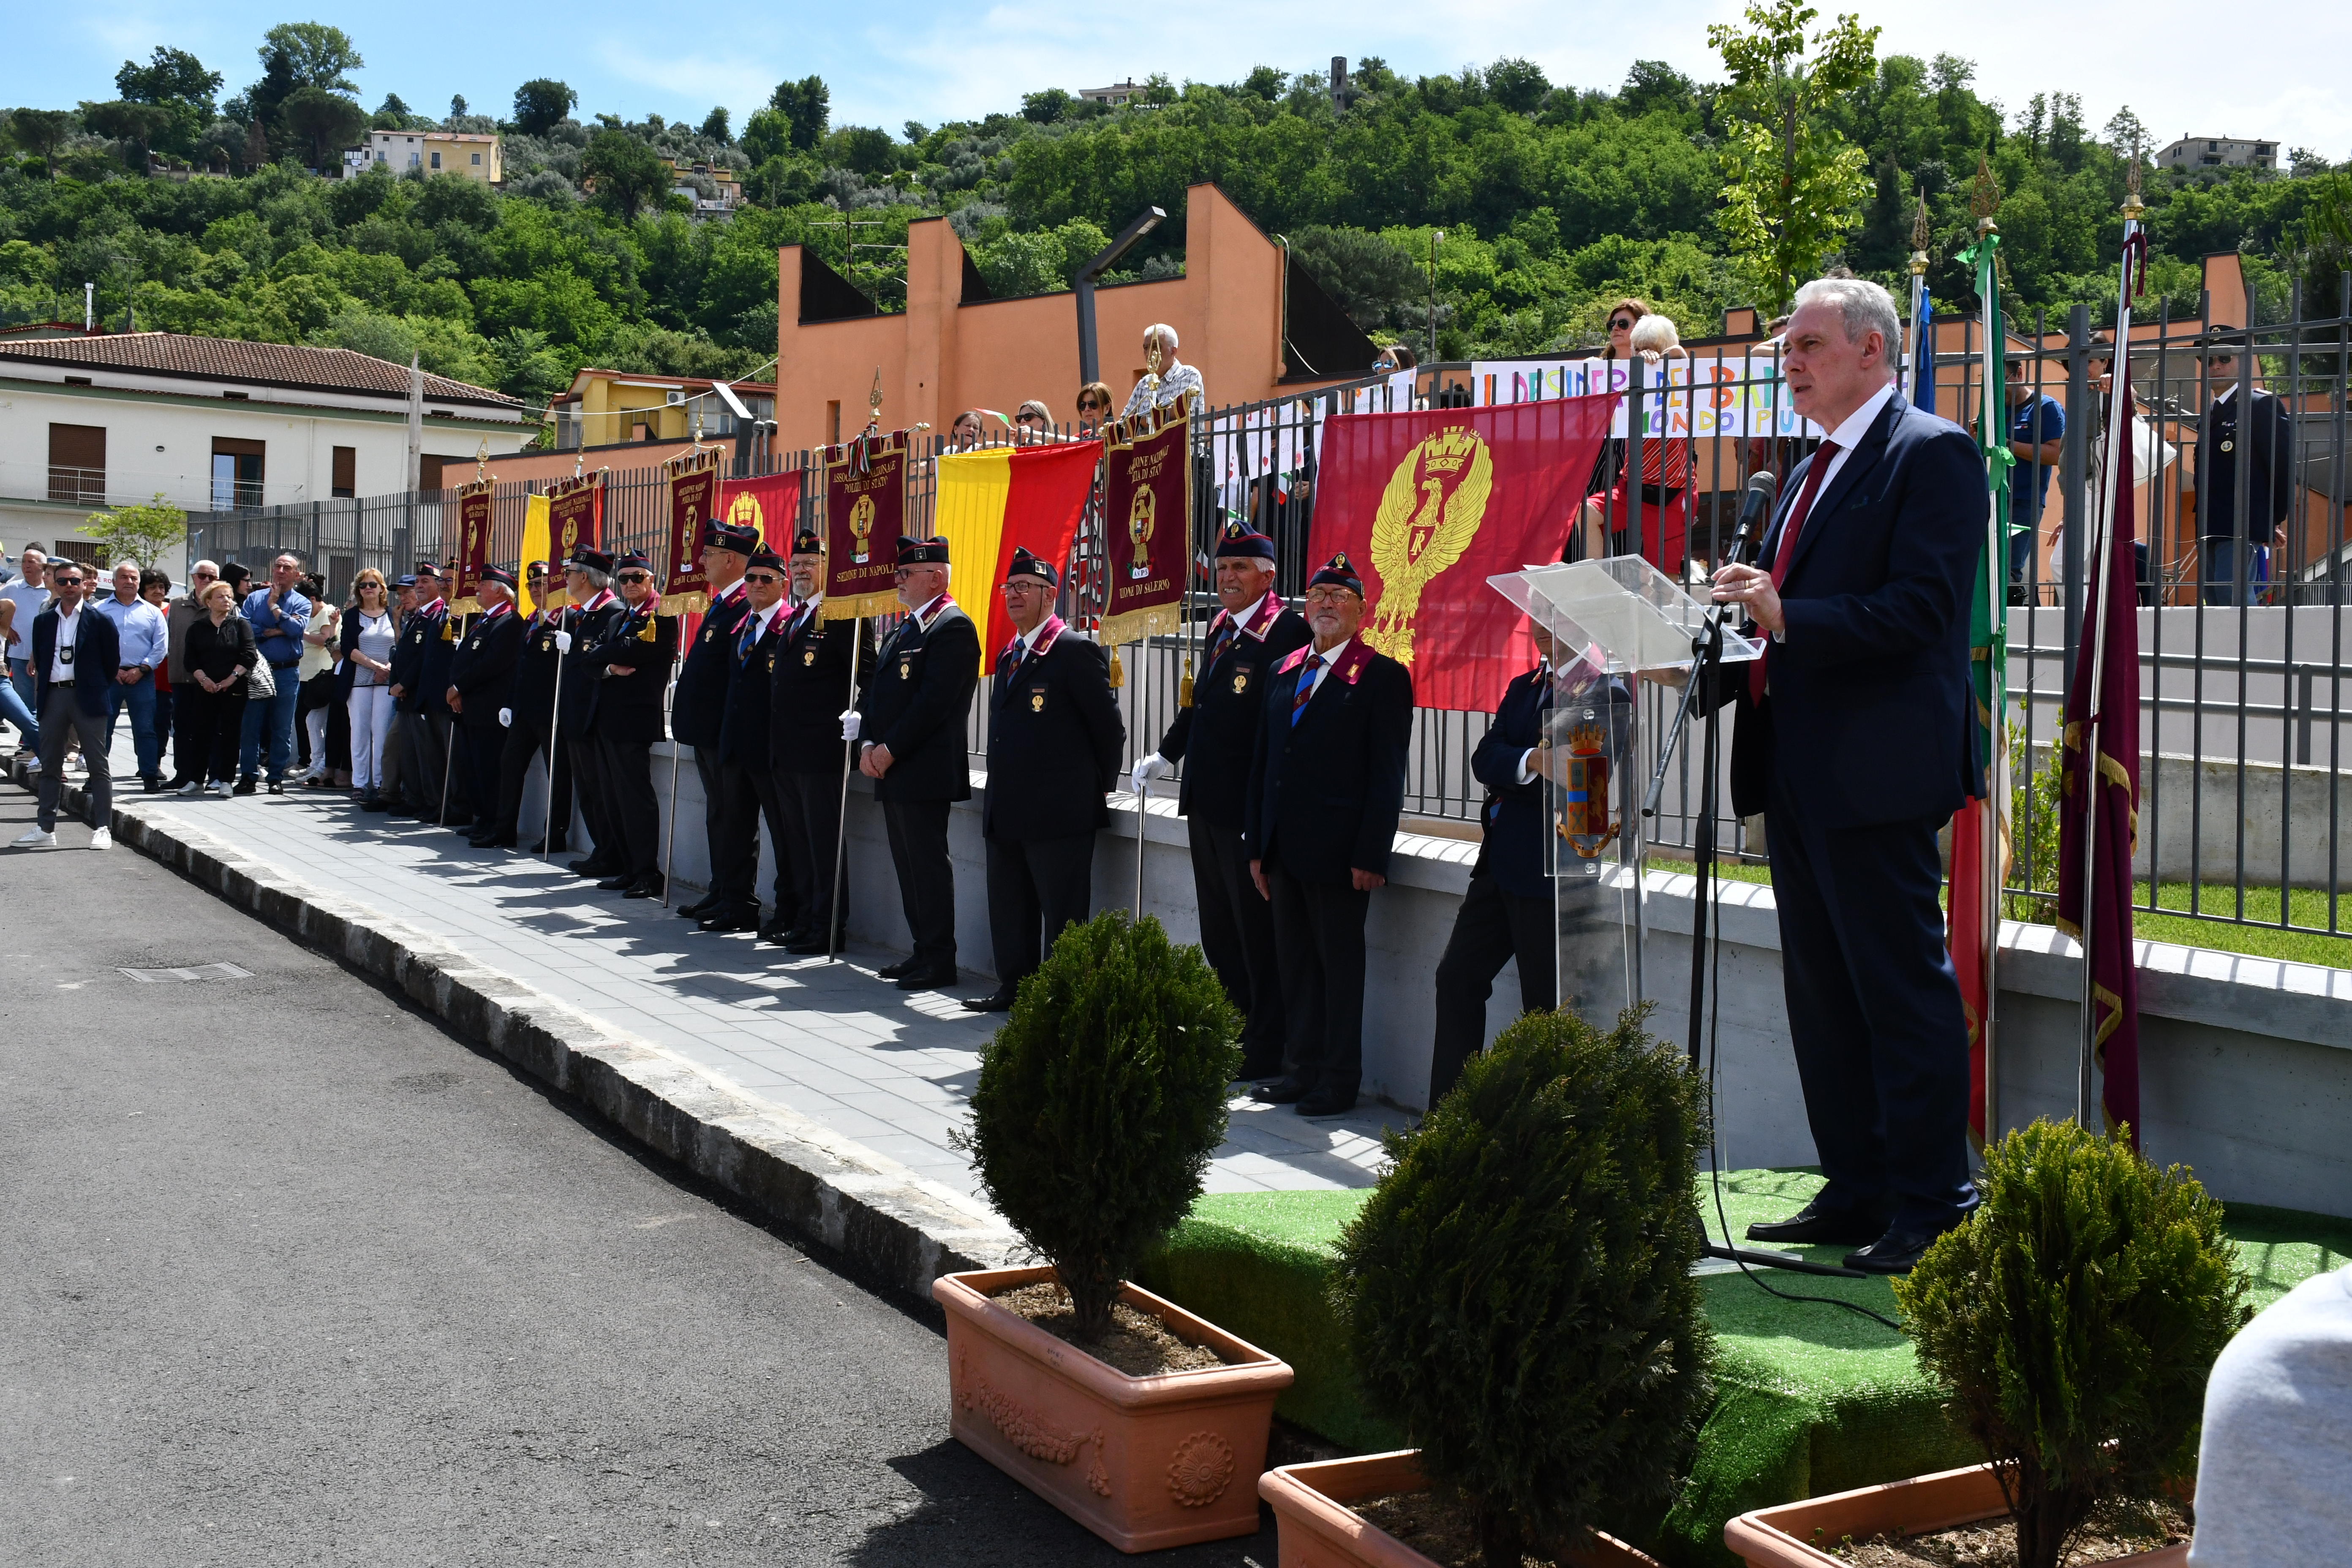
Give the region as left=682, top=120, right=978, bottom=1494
left=1242, top=555, right=1413, bottom=1116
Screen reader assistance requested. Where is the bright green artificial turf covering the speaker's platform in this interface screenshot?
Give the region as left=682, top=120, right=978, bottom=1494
left=1136, top=1168, right=2352, bottom=1563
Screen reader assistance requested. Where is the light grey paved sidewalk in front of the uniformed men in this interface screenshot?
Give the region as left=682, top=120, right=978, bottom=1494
left=18, top=736, right=1411, bottom=1194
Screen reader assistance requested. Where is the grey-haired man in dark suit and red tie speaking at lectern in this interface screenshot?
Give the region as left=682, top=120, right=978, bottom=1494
left=1715, top=278, right=1987, bottom=1274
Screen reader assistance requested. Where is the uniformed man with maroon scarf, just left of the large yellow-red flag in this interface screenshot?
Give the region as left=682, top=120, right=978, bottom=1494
left=842, top=536, right=981, bottom=990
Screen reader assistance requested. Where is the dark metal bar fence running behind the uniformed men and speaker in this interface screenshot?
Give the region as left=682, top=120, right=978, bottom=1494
left=191, top=298, right=2352, bottom=933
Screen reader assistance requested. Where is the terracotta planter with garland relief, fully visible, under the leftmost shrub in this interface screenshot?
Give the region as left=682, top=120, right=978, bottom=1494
left=931, top=1269, right=1291, bottom=1552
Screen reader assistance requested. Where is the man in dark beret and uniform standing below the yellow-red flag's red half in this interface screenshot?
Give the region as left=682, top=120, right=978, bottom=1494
left=964, top=550, right=1127, bottom=1013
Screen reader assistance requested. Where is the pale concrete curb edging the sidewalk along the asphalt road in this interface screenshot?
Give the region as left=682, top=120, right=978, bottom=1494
left=7, top=760, right=1026, bottom=1305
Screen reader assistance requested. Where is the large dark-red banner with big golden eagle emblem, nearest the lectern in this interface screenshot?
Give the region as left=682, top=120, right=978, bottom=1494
left=1305, top=392, right=1623, bottom=712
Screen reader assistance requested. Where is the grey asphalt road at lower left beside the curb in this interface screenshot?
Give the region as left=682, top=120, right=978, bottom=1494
left=0, top=785, right=1275, bottom=1568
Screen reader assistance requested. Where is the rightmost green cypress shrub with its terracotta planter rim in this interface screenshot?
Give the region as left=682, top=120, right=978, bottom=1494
left=1724, top=1122, right=2253, bottom=1568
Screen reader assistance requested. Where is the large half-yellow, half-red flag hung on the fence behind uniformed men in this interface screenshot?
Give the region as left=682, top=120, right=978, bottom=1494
left=934, top=442, right=1105, bottom=670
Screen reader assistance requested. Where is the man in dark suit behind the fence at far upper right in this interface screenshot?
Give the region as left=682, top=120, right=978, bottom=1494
left=2194, top=327, right=2295, bottom=604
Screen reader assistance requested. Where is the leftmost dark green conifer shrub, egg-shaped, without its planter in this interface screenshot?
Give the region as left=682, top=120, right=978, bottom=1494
left=960, top=910, right=1242, bottom=1340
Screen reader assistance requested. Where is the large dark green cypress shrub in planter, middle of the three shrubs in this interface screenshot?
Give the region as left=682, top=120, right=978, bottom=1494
left=1258, top=1011, right=1712, bottom=1568
